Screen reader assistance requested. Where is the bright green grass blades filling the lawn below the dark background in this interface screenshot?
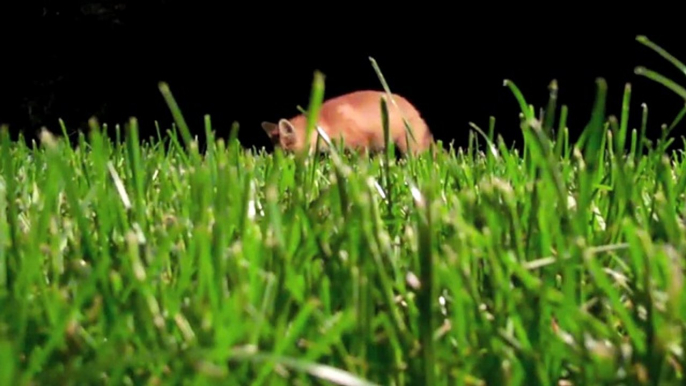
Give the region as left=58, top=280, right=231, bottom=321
left=0, top=38, right=686, bottom=385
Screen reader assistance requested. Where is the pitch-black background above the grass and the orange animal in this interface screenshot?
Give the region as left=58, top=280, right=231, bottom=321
left=0, top=0, right=686, bottom=151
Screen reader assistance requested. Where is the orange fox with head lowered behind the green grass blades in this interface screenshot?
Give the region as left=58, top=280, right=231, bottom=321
left=262, top=90, right=433, bottom=154
